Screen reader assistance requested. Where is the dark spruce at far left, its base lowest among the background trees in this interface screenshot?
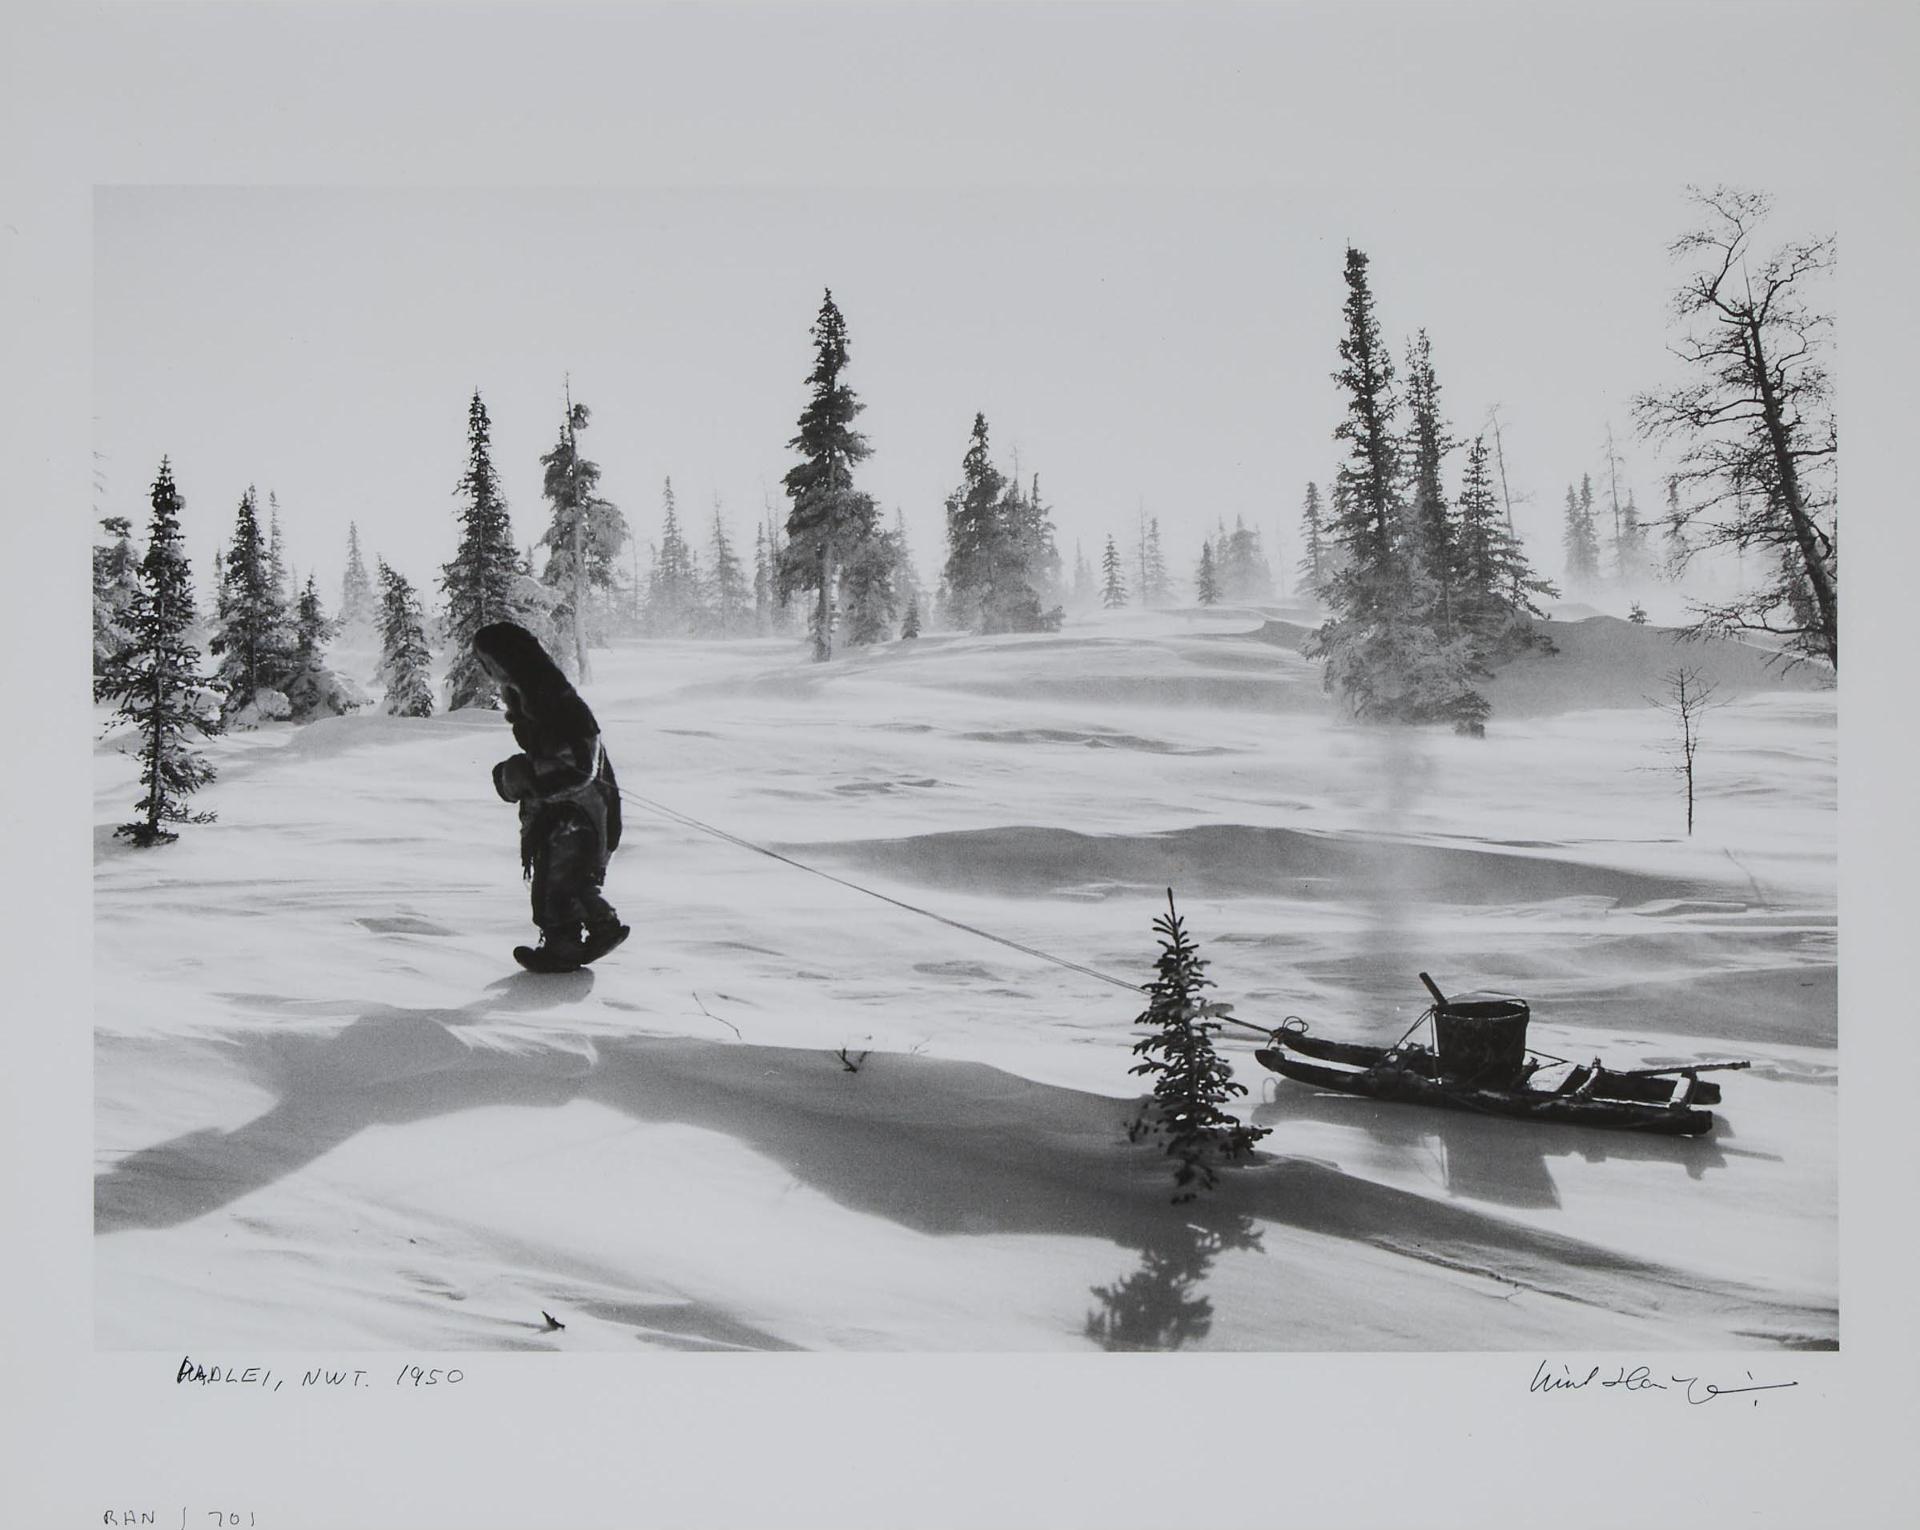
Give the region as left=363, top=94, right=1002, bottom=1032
left=106, top=459, right=219, bottom=847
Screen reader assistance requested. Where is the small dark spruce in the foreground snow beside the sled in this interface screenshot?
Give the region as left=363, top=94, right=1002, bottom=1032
left=1131, top=887, right=1267, bottom=1206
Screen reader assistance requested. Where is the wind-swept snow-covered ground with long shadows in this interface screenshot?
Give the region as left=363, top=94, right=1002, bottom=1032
left=94, top=610, right=1837, bottom=1351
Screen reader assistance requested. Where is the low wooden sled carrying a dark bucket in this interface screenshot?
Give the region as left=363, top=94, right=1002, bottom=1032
left=1254, top=973, right=1749, bottom=1136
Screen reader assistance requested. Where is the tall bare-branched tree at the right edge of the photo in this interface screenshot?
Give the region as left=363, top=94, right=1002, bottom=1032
left=1634, top=188, right=1839, bottom=672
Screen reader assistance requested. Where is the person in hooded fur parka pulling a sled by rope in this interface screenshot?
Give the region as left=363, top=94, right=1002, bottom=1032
left=472, top=622, right=628, bottom=971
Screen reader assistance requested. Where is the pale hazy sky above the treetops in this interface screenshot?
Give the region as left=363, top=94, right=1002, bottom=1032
left=94, top=182, right=1811, bottom=601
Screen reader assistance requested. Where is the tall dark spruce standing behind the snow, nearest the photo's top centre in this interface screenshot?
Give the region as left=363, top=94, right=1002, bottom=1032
left=778, top=288, right=879, bottom=660
